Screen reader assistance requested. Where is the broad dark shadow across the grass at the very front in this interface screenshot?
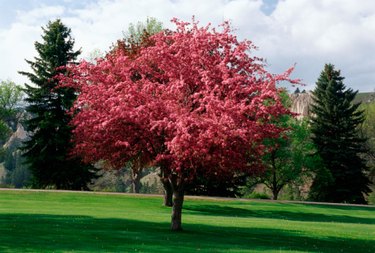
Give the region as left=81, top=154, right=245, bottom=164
left=0, top=214, right=375, bottom=253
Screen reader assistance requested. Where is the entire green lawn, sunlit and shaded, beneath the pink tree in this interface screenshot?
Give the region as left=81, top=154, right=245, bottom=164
left=0, top=191, right=375, bottom=253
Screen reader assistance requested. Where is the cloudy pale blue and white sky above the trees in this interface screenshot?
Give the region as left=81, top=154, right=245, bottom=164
left=0, top=0, right=375, bottom=92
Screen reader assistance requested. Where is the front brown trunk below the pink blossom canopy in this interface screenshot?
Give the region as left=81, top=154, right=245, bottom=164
left=170, top=175, right=184, bottom=231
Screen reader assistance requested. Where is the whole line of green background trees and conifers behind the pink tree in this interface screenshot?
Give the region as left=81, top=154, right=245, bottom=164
left=0, top=19, right=375, bottom=208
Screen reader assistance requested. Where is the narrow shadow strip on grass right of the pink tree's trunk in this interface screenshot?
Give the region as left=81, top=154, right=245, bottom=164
left=184, top=205, right=375, bottom=224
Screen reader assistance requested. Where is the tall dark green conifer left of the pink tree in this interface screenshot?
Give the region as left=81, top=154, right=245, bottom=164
left=19, top=19, right=95, bottom=190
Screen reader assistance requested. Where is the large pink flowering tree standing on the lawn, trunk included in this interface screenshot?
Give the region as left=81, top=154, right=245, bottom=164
left=62, top=19, right=293, bottom=230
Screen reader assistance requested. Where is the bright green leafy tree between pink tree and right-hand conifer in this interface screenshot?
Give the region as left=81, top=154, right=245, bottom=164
left=258, top=117, right=320, bottom=199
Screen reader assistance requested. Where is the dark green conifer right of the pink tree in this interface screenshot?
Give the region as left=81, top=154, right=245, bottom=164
left=310, top=64, right=370, bottom=204
